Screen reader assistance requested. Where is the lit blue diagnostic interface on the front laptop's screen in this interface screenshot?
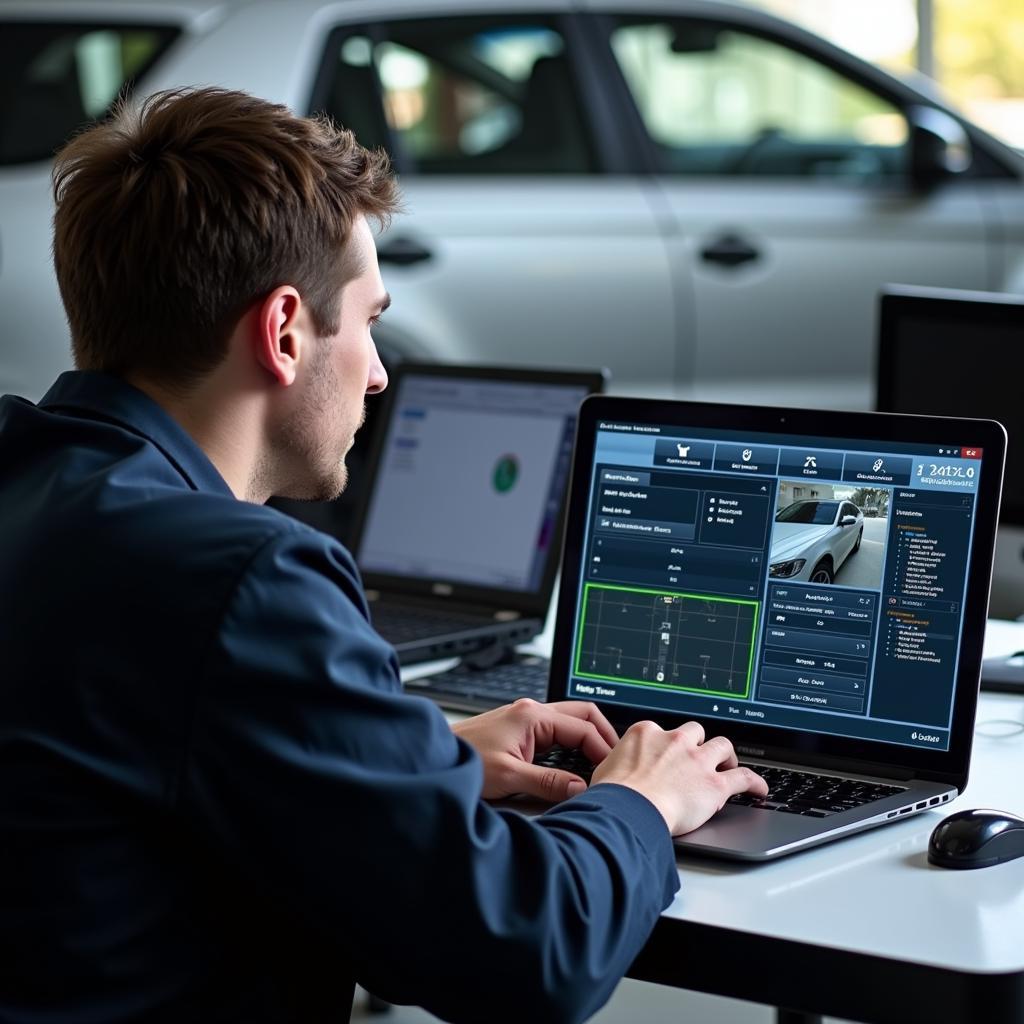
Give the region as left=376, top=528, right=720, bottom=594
left=568, top=423, right=982, bottom=750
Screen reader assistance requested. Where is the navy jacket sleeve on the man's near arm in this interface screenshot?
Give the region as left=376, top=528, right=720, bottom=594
left=177, top=530, right=679, bottom=1024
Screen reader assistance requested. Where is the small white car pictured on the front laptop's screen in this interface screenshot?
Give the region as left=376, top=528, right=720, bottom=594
left=768, top=499, right=864, bottom=583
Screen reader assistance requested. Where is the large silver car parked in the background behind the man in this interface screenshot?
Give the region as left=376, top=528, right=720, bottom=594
left=0, top=0, right=1024, bottom=407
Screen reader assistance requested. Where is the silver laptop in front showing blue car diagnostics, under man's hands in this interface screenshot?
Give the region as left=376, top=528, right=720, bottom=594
left=548, top=395, right=1006, bottom=860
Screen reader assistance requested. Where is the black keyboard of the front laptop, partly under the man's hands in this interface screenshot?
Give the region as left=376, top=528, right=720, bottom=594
left=534, top=746, right=905, bottom=818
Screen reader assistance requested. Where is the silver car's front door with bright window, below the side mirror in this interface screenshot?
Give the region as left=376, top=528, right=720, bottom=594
left=597, top=3, right=990, bottom=408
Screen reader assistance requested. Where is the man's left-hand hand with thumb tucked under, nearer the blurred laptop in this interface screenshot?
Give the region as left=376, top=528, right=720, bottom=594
left=452, top=697, right=618, bottom=803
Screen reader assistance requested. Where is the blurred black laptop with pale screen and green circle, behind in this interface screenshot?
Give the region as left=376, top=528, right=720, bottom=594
left=352, top=364, right=604, bottom=664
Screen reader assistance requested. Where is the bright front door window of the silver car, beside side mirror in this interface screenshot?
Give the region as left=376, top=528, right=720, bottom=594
left=611, top=17, right=907, bottom=180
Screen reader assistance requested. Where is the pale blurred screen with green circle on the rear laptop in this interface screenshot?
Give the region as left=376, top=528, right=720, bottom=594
left=356, top=368, right=600, bottom=593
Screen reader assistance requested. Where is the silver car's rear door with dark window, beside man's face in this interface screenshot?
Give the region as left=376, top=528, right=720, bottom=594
left=312, top=14, right=678, bottom=388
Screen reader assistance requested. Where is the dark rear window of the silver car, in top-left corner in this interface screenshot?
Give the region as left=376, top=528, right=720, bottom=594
left=0, top=22, right=178, bottom=164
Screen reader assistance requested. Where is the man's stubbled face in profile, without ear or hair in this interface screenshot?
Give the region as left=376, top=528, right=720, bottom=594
left=278, top=216, right=390, bottom=501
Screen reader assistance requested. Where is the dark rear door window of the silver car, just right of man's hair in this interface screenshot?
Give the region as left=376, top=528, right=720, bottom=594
left=314, top=17, right=596, bottom=174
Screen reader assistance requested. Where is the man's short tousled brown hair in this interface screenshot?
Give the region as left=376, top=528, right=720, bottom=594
left=53, top=88, right=397, bottom=385
